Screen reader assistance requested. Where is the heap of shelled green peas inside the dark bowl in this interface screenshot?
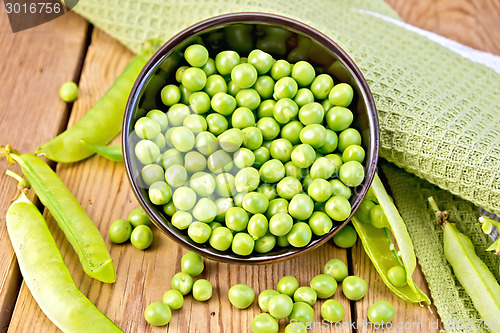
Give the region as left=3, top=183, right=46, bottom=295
left=131, top=44, right=365, bottom=256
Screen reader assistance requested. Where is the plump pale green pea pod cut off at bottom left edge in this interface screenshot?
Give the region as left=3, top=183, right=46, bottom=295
left=6, top=172, right=122, bottom=333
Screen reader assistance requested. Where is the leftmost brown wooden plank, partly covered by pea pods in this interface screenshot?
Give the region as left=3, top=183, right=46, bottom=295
left=0, top=10, right=88, bottom=331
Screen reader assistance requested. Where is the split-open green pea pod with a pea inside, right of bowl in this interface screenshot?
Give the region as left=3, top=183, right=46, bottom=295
left=352, top=174, right=431, bottom=304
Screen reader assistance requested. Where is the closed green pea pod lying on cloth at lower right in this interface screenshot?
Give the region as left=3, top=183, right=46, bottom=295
left=429, top=197, right=500, bottom=333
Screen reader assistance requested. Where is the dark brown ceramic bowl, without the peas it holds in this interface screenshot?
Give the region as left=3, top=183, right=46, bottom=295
left=123, top=13, right=379, bottom=264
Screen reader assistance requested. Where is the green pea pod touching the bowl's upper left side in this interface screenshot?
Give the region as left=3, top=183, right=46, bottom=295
left=35, top=40, right=159, bottom=163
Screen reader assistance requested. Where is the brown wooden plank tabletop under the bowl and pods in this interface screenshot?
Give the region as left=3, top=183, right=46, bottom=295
left=0, top=0, right=500, bottom=333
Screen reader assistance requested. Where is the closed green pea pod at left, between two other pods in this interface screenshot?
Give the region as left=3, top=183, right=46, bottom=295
left=0, top=146, right=116, bottom=283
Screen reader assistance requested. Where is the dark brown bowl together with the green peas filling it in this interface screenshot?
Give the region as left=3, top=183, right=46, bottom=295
left=124, top=14, right=378, bottom=263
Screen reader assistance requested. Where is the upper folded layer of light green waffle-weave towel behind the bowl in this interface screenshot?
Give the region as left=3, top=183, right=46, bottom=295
left=74, top=0, right=500, bottom=215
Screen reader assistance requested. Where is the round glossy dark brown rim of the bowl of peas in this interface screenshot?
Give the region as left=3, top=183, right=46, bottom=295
left=122, top=12, right=380, bottom=264
